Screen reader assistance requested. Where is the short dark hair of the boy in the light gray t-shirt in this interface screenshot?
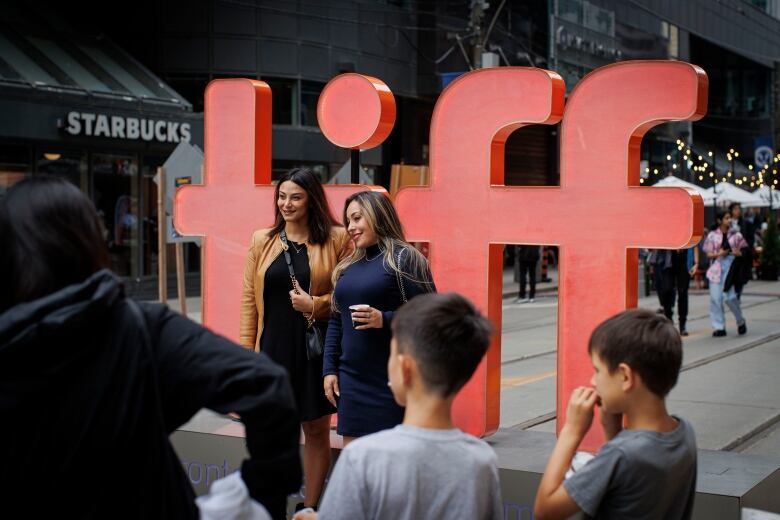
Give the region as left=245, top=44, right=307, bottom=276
left=392, top=293, right=493, bottom=397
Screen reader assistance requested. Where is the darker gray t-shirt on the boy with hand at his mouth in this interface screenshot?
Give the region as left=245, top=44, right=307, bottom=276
left=563, top=417, right=696, bottom=520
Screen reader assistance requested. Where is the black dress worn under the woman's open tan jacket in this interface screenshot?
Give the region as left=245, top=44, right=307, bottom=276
left=260, top=242, right=336, bottom=421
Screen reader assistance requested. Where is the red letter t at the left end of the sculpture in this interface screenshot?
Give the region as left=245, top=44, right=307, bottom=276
left=174, top=79, right=386, bottom=341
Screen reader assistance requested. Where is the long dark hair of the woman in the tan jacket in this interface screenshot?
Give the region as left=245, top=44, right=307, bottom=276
left=269, top=168, right=339, bottom=245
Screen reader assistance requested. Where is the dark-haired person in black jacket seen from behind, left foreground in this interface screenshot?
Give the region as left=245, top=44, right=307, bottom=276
left=0, top=178, right=301, bottom=518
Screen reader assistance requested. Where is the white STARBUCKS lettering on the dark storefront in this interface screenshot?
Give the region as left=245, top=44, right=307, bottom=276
left=65, top=110, right=190, bottom=143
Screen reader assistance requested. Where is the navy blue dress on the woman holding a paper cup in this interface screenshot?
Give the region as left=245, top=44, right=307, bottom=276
left=323, top=245, right=435, bottom=437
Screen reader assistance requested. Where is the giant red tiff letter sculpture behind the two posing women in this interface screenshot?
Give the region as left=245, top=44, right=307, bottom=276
left=175, top=61, right=707, bottom=449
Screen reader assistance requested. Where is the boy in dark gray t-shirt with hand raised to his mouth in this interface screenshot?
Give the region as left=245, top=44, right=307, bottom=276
left=535, top=310, right=696, bottom=520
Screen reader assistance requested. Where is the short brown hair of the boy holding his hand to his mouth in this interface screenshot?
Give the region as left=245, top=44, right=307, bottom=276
left=588, top=309, right=682, bottom=397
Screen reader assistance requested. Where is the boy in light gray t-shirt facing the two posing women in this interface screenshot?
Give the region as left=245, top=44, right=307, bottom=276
left=295, top=293, right=503, bottom=520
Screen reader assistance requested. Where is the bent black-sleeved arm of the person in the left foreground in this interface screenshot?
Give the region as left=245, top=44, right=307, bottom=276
left=143, top=305, right=301, bottom=517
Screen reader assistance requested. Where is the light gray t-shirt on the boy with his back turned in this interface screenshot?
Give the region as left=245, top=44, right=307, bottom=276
left=319, top=425, right=503, bottom=520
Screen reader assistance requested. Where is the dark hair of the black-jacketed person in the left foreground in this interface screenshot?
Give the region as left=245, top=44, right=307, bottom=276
left=0, top=177, right=109, bottom=312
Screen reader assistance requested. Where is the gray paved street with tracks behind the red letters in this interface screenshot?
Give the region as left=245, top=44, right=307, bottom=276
left=169, top=271, right=780, bottom=456
